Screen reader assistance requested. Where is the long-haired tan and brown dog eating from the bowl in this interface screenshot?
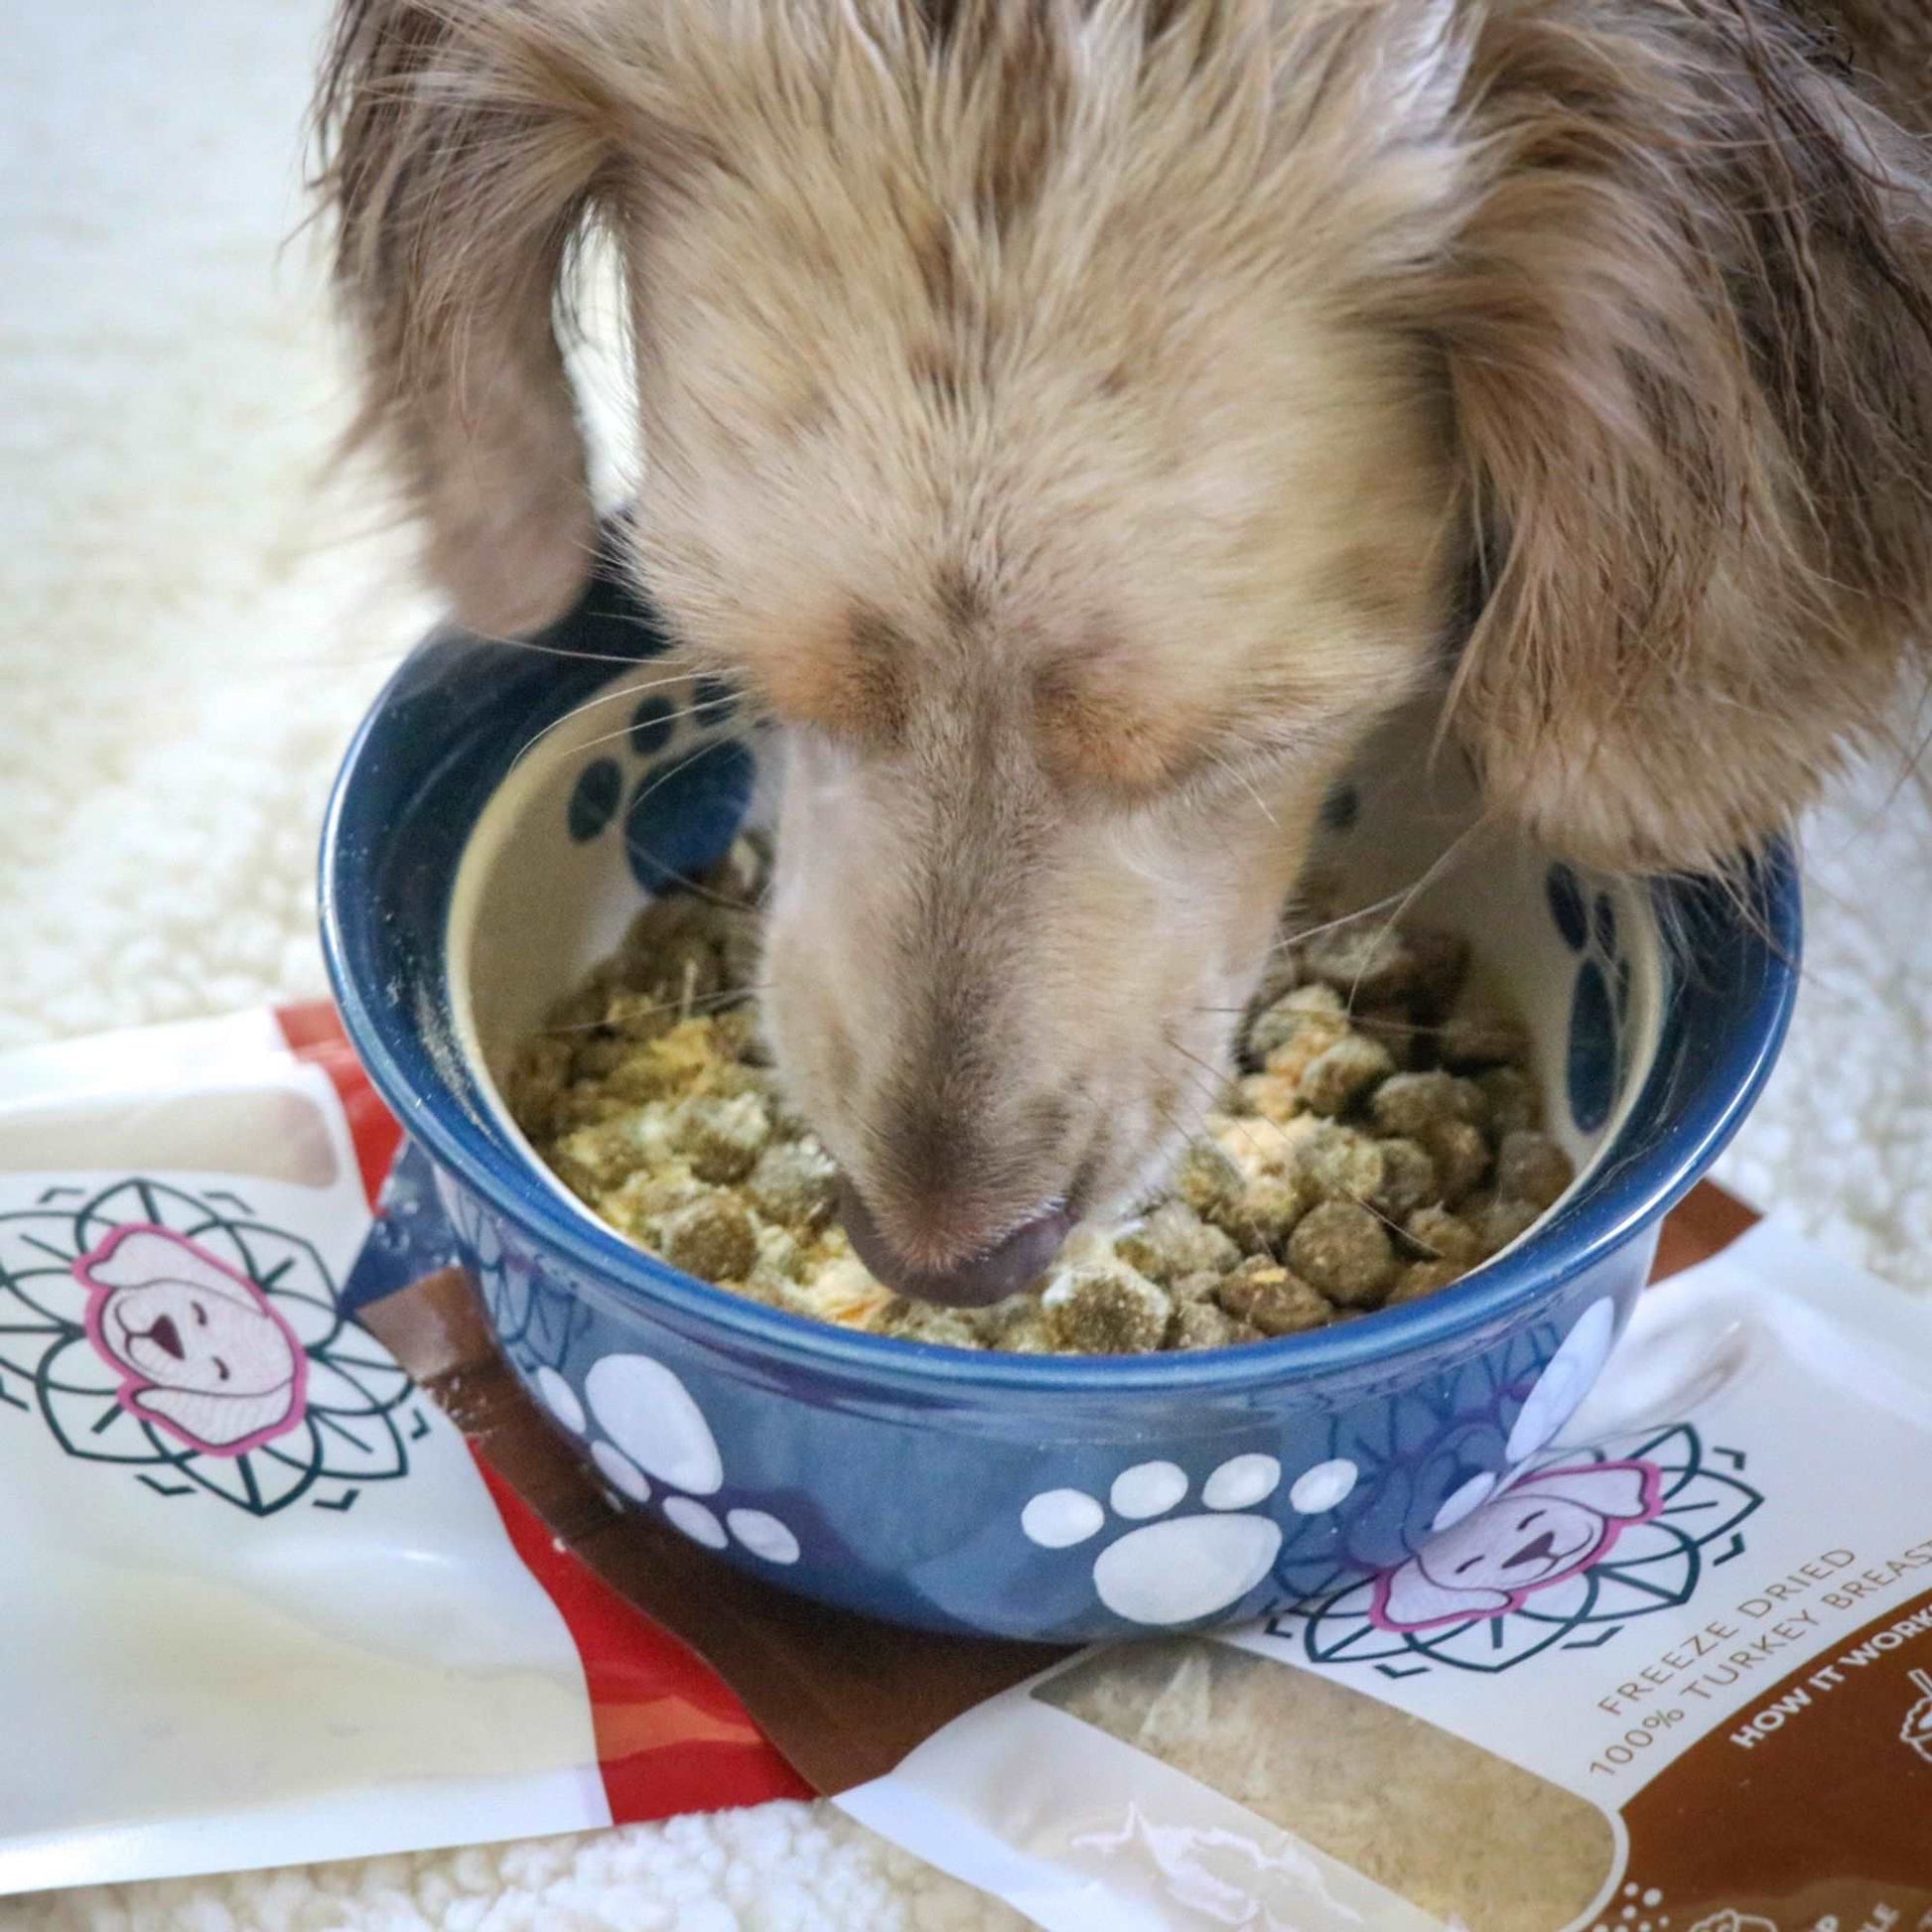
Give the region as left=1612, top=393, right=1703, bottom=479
left=317, top=0, right=1932, bottom=1301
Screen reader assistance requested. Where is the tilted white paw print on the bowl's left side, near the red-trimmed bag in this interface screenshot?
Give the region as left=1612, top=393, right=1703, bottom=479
left=535, top=1354, right=798, bottom=1563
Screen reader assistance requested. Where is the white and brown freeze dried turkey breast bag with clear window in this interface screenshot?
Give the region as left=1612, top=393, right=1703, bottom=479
left=841, top=1223, right=1932, bottom=1932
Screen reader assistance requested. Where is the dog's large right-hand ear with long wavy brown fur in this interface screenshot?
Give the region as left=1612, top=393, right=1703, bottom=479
left=1424, top=0, right=1932, bottom=872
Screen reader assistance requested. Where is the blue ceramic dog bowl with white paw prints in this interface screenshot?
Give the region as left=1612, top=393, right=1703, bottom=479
left=323, top=552, right=1799, bottom=1640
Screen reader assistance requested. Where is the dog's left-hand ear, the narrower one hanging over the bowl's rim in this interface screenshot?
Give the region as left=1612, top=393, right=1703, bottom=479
left=315, top=0, right=615, bottom=635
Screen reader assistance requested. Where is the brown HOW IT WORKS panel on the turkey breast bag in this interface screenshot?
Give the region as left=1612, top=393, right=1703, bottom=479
left=1603, top=1592, right=1932, bottom=1932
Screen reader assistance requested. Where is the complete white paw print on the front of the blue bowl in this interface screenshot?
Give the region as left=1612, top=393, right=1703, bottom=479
left=1020, top=1454, right=1360, bottom=1628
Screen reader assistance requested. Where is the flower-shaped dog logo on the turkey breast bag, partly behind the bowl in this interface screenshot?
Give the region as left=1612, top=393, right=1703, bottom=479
left=1268, top=1422, right=1764, bottom=1677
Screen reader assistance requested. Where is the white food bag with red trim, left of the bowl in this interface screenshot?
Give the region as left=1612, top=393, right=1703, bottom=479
left=0, top=1007, right=805, bottom=1891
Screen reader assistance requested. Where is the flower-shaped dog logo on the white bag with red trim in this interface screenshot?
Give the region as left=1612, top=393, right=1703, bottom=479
left=0, top=1176, right=429, bottom=1517
